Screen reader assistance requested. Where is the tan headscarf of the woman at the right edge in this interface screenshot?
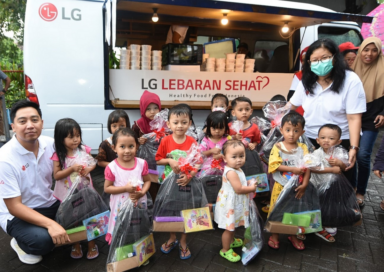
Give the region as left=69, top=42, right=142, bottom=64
left=352, top=37, right=384, bottom=103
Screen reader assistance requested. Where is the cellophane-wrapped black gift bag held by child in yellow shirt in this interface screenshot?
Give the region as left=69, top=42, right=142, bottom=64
left=267, top=151, right=323, bottom=234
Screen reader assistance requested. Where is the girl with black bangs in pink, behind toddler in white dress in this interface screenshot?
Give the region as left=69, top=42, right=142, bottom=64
left=200, top=111, right=229, bottom=175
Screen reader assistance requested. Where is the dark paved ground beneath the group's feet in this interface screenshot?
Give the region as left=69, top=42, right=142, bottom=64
left=0, top=132, right=384, bottom=272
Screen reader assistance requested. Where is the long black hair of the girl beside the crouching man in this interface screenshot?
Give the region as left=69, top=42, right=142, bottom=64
left=53, top=118, right=83, bottom=168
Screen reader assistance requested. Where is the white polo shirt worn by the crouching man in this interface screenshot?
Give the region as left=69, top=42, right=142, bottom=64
left=0, top=136, right=57, bottom=232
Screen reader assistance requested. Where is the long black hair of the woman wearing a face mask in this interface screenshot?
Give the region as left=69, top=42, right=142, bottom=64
left=302, top=39, right=349, bottom=94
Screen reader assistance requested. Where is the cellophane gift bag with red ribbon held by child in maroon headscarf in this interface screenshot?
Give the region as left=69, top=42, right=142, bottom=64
left=137, top=109, right=169, bottom=182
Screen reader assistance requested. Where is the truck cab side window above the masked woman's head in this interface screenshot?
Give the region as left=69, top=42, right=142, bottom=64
left=318, top=26, right=363, bottom=46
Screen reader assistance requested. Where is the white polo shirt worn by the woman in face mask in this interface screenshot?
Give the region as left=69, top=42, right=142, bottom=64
left=290, top=71, right=367, bottom=139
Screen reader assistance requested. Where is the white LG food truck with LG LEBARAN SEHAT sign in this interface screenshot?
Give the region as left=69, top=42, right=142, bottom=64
left=24, top=0, right=372, bottom=152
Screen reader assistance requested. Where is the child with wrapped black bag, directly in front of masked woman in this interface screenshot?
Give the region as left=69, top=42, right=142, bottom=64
left=310, top=124, right=361, bottom=243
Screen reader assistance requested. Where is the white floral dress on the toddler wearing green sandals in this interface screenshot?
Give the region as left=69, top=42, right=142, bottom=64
left=214, top=166, right=249, bottom=231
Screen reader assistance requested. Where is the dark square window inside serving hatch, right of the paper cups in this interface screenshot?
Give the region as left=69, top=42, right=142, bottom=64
left=253, top=41, right=289, bottom=73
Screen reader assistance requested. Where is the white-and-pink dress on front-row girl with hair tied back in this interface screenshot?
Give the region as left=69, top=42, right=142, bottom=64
left=104, top=158, right=148, bottom=242
